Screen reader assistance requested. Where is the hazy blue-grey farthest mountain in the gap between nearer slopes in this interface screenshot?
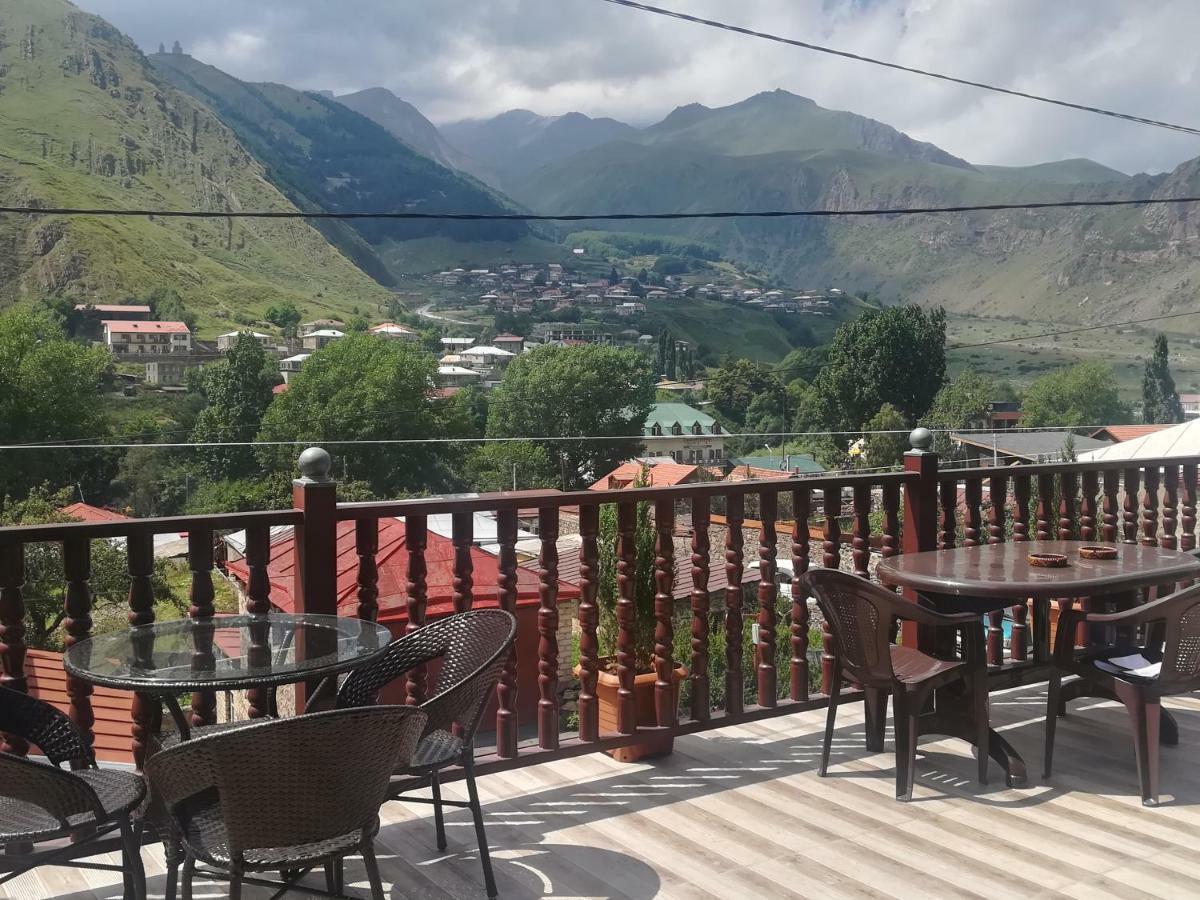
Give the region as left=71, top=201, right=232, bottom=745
left=442, top=109, right=637, bottom=185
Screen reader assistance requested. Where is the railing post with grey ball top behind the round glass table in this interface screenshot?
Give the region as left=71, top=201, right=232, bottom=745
left=292, top=446, right=337, bottom=709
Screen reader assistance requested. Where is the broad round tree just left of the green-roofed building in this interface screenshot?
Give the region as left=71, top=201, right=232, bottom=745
left=487, top=344, right=654, bottom=487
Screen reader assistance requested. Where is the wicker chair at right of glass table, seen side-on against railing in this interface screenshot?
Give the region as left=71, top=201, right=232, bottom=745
left=337, top=610, right=517, bottom=898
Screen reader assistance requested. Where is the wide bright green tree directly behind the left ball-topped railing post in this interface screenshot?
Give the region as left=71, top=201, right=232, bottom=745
left=259, top=335, right=450, bottom=497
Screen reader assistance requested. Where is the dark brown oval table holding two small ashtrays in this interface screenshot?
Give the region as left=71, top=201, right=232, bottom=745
left=877, top=541, right=1200, bottom=787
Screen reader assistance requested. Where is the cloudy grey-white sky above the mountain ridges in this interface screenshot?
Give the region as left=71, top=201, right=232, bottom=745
left=77, top=0, right=1200, bottom=173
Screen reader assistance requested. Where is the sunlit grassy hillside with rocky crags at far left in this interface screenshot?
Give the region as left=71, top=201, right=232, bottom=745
left=0, top=0, right=388, bottom=331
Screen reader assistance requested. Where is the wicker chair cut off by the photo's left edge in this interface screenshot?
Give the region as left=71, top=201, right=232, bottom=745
left=0, top=688, right=146, bottom=900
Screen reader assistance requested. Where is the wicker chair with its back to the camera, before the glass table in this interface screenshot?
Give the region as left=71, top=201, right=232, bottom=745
left=146, top=707, right=426, bottom=900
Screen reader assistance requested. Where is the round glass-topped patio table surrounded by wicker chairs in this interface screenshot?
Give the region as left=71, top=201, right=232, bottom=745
left=64, top=613, right=391, bottom=740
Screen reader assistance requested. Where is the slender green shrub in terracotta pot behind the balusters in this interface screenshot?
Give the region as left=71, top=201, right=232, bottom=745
left=576, top=478, right=688, bottom=762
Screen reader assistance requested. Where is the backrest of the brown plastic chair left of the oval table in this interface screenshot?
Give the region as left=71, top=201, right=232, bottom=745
left=800, top=569, right=902, bottom=688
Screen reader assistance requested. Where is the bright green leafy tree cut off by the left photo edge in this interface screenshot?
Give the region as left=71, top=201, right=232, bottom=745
left=0, top=308, right=113, bottom=505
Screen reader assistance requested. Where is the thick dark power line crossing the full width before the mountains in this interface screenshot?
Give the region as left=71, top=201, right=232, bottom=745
left=0, top=194, right=1200, bottom=222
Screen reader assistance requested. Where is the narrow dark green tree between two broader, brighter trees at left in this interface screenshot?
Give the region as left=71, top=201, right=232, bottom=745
left=192, top=332, right=278, bottom=481
